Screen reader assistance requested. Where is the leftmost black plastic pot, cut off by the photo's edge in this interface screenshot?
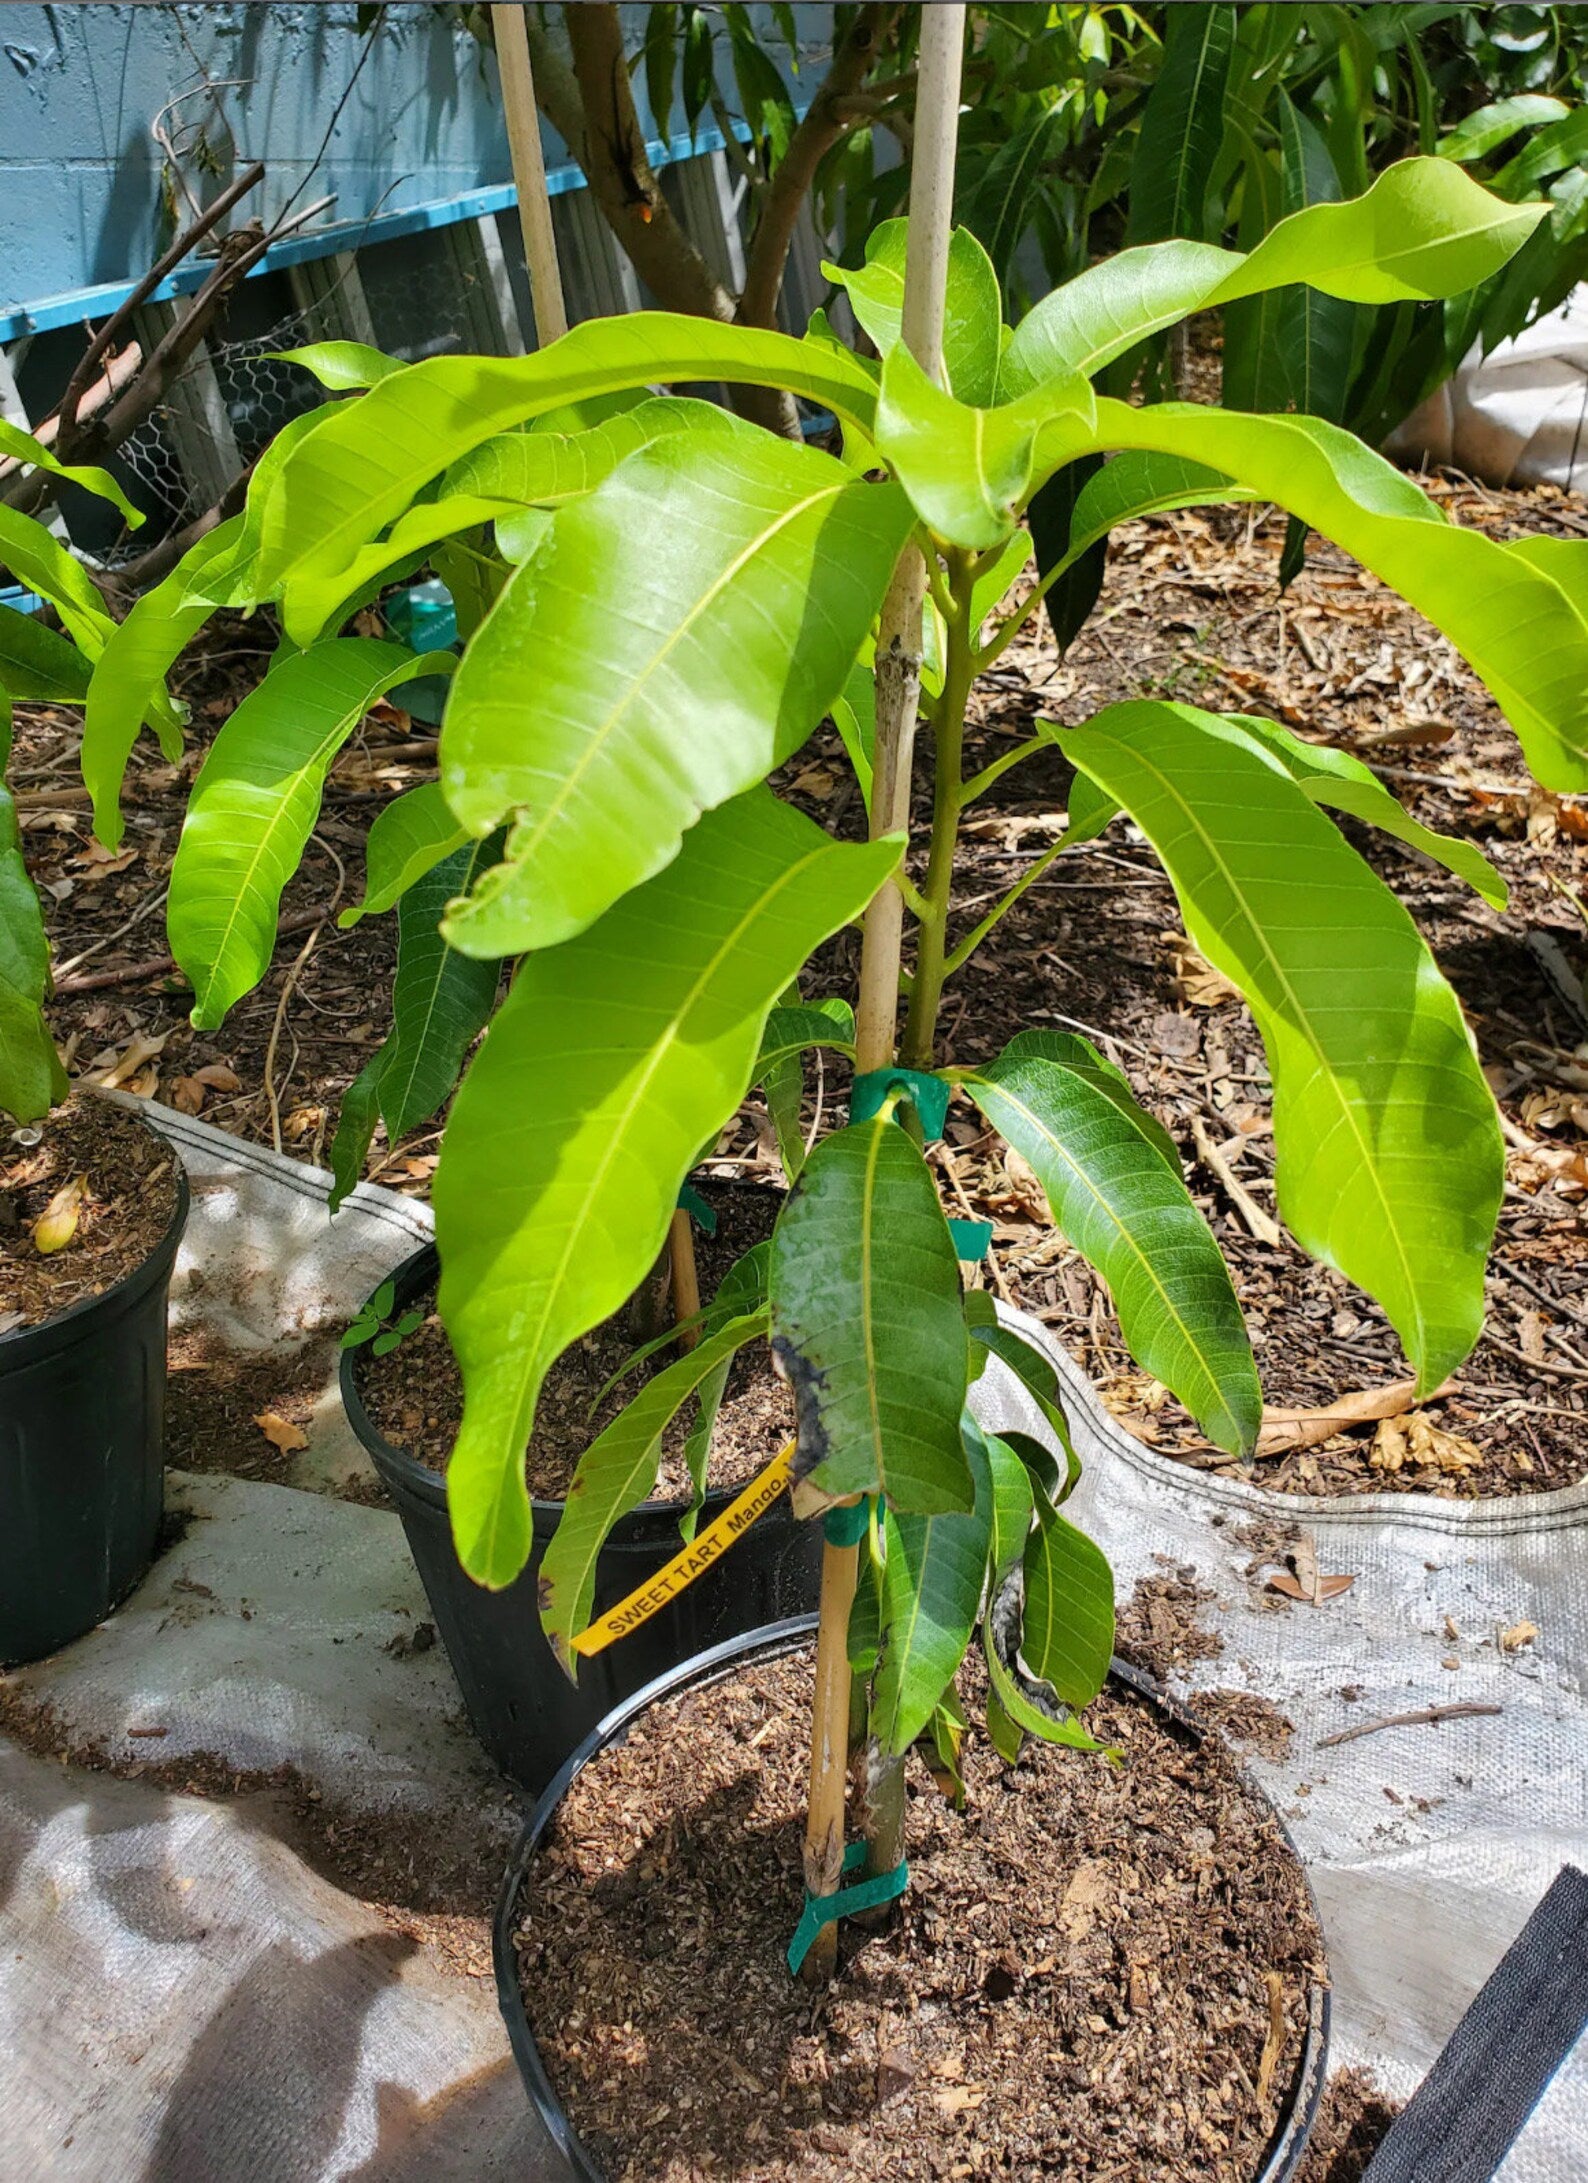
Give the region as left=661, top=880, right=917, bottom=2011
left=0, top=1150, right=188, bottom=1668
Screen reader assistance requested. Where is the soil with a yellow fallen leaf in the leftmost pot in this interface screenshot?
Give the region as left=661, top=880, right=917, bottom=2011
left=0, top=1096, right=177, bottom=1334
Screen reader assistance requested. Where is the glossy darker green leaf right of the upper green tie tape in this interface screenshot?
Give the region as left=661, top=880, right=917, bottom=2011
left=961, top=1039, right=1263, bottom=1454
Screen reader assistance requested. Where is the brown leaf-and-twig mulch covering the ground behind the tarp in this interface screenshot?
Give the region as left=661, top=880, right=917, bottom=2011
left=11, top=476, right=1588, bottom=1495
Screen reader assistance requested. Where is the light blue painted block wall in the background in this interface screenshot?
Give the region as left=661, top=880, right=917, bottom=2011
left=0, top=0, right=832, bottom=338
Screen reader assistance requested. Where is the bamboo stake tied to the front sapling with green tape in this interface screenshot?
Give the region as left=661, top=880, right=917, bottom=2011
left=804, top=4, right=965, bottom=1984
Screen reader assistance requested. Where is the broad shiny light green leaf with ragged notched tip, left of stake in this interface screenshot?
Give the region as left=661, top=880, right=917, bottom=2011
left=441, top=432, right=909, bottom=954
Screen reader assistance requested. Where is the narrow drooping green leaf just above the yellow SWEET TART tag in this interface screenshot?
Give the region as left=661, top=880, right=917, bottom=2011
left=543, top=1314, right=767, bottom=1681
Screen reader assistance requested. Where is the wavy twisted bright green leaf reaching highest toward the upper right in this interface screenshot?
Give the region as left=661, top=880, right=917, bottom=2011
left=998, top=159, right=1544, bottom=399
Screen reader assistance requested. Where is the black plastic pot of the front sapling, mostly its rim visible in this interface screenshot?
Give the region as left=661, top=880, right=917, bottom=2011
left=491, top=1613, right=1328, bottom=2183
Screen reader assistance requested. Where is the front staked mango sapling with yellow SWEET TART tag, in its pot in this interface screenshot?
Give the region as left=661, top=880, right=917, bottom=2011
left=105, top=34, right=1588, bottom=2183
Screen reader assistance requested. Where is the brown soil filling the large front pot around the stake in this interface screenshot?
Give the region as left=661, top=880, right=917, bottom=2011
left=518, top=1655, right=1322, bottom=2183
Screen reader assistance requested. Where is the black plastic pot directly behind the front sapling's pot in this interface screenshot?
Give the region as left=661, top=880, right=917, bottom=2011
left=341, top=1244, right=821, bottom=1797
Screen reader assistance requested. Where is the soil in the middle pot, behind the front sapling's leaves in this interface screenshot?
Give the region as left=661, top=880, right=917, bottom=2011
left=354, top=1181, right=793, bottom=1502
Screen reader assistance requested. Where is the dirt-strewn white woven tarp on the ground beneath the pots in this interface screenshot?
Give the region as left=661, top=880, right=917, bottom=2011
left=0, top=1111, right=1588, bottom=2183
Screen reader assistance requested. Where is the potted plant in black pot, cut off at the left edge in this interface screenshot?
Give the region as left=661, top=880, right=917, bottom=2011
left=0, top=426, right=188, bottom=1666
